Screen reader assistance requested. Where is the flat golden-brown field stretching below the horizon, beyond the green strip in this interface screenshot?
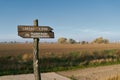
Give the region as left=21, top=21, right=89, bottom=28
left=0, top=43, right=120, bottom=56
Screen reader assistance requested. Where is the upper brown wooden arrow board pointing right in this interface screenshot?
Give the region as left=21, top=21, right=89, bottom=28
left=18, top=25, right=53, bottom=32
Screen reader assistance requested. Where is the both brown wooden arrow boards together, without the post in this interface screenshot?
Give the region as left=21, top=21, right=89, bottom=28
left=18, top=25, right=54, bottom=38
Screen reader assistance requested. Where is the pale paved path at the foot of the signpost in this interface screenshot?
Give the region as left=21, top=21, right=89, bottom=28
left=0, top=72, right=70, bottom=80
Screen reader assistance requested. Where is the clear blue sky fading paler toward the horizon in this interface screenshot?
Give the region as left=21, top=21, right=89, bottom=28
left=0, top=0, right=120, bottom=42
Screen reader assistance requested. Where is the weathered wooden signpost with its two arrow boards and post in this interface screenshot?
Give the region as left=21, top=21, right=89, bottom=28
left=18, top=20, right=54, bottom=80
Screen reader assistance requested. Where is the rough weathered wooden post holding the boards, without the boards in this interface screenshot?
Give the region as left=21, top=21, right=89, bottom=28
left=33, top=20, right=41, bottom=80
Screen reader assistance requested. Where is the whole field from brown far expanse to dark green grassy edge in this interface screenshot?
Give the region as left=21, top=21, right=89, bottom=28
left=0, top=43, right=120, bottom=80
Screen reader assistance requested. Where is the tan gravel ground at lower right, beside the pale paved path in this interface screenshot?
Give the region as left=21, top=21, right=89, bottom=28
left=58, top=64, right=120, bottom=80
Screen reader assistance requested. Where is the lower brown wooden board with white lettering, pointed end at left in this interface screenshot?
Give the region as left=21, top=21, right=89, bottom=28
left=18, top=32, right=54, bottom=38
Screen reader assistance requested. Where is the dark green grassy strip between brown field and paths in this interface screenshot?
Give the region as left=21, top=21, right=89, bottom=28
left=0, top=50, right=120, bottom=76
